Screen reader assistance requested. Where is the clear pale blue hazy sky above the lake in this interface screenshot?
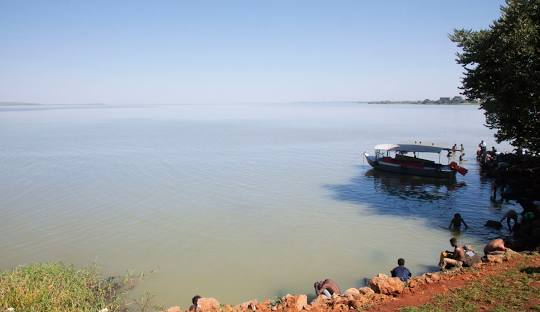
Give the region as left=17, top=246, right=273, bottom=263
left=0, top=0, right=503, bottom=104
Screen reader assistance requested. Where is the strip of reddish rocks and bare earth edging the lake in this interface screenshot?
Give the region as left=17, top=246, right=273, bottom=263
left=161, top=249, right=540, bottom=312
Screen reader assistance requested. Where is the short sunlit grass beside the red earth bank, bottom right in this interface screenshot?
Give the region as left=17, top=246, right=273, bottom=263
left=401, top=260, right=540, bottom=312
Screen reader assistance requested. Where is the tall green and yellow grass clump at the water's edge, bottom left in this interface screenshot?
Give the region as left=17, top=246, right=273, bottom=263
left=0, top=263, right=123, bottom=312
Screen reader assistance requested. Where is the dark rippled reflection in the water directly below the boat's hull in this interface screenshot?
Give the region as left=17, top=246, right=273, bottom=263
left=365, top=169, right=466, bottom=201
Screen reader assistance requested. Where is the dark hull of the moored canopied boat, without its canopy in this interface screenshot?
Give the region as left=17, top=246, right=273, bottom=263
left=365, top=154, right=456, bottom=179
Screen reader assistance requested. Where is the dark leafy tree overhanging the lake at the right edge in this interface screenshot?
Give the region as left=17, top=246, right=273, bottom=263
left=450, top=0, right=540, bottom=154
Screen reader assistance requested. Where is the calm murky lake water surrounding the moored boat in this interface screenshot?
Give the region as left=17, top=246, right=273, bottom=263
left=0, top=103, right=510, bottom=306
